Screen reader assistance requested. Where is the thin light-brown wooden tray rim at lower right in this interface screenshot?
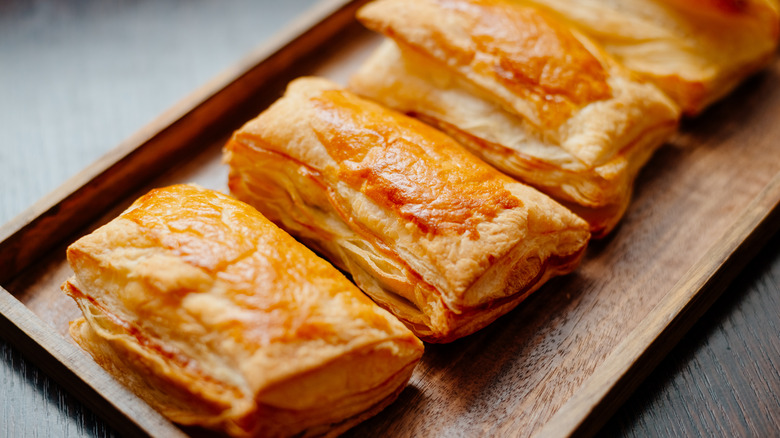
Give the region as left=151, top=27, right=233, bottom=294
left=534, top=173, right=780, bottom=437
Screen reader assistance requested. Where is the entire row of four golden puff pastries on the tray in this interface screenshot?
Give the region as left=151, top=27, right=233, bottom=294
left=63, top=0, right=778, bottom=436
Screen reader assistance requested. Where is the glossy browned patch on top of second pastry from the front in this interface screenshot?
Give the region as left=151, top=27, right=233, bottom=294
left=312, top=90, right=521, bottom=238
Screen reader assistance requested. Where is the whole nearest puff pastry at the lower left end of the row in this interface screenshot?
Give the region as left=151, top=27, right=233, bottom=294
left=63, top=185, right=423, bottom=436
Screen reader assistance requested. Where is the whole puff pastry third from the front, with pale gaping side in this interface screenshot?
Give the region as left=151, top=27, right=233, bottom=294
left=349, top=0, right=679, bottom=237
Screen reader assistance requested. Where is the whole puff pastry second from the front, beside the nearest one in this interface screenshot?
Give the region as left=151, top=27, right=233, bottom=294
left=225, top=78, right=589, bottom=342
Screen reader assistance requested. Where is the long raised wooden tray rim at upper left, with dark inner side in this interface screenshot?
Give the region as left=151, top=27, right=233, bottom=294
left=0, top=0, right=366, bottom=284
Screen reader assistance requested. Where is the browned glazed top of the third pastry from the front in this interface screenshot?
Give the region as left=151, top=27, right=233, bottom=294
left=358, top=0, right=612, bottom=126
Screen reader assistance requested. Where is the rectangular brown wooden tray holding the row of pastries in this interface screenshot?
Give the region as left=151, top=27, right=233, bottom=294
left=0, top=1, right=780, bottom=437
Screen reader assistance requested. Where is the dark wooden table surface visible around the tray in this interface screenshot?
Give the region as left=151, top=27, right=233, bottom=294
left=0, top=0, right=780, bottom=437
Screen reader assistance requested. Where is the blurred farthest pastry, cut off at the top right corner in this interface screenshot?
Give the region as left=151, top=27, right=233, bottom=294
left=516, top=0, right=780, bottom=115
